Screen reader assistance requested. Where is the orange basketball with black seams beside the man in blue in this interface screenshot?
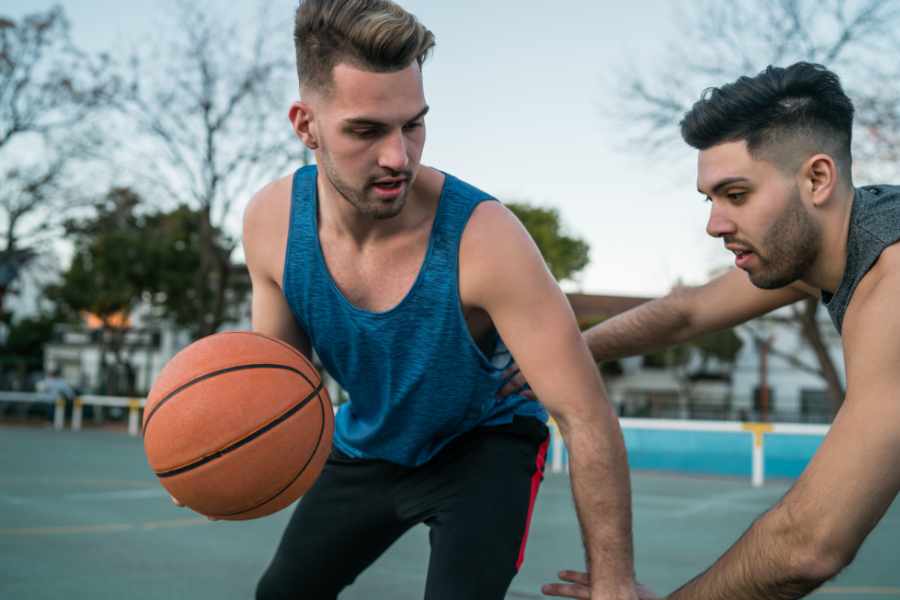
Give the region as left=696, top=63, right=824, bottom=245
left=143, top=331, right=334, bottom=520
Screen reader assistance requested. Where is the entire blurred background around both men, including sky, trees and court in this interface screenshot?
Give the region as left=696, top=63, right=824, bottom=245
left=0, top=0, right=900, bottom=600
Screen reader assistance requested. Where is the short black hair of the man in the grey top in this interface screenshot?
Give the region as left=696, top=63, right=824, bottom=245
left=681, top=62, right=853, bottom=185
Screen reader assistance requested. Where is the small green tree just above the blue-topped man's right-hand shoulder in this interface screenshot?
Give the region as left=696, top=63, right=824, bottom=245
left=506, top=202, right=590, bottom=281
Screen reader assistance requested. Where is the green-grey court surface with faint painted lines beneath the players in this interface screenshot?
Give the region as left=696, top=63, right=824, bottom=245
left=0, top=426, right=900, bottom=600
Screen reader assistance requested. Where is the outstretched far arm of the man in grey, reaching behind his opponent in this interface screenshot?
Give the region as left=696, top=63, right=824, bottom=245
left=584, top=269, right=815, bottom=362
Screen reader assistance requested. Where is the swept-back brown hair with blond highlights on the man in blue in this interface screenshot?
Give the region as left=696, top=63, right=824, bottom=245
left=294, top=0, right=435, bottom=91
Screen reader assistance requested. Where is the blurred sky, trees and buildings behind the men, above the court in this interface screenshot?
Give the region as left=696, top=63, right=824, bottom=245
left=7, top=0, right=900, bottom=422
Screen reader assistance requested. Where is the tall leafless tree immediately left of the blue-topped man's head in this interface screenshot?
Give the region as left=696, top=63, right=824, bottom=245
left=112, top=2, right=307, bottom=337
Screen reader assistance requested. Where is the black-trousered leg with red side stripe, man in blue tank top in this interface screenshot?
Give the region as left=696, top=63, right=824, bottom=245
left=425, top=418, right=548, bottom=600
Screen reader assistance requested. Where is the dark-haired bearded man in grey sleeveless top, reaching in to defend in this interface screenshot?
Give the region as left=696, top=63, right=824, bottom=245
left=512, top=63, right=900, bottom=600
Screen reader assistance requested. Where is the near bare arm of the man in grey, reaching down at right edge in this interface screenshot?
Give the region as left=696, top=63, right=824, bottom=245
left=670, top=261, right=900, bottom=600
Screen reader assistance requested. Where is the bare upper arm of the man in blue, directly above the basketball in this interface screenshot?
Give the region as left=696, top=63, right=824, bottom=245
left=243, top=182, right=311, bottom=358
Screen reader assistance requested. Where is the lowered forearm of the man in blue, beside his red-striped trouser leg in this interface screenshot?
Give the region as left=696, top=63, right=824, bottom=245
left=561, top=411, right=634, bottom=598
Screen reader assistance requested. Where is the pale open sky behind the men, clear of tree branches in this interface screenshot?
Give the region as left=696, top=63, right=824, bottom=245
left=0, top=0, right=730, bottom=296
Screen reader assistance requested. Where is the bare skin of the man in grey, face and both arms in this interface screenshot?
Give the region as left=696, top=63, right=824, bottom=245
left=536, top=142, right=900, bottom=600
